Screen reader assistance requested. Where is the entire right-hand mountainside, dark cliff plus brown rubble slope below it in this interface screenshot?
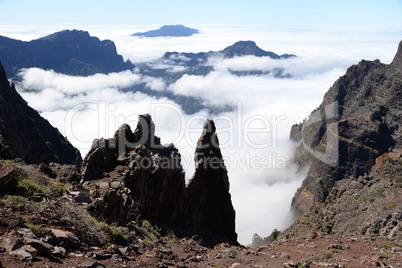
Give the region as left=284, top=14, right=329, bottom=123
left=291, top=42, right=402, bottom=243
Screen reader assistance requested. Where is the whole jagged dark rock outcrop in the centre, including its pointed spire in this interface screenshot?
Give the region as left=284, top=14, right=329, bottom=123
left=82, top=115, right=237, bottom=244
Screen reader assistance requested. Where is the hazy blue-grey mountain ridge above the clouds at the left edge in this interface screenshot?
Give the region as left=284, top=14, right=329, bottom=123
left=0, top=30, right=134, bottom=78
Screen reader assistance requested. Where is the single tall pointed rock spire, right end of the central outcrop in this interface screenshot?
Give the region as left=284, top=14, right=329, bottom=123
left=186, top=120, right=237, bottom=244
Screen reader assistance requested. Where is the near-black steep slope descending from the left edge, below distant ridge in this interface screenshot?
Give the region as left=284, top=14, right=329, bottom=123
left=0, top=63, right=81, bottom=164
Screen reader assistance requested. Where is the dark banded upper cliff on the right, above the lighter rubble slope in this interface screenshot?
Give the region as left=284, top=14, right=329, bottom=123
left=291, top=40, right=402, bottom=218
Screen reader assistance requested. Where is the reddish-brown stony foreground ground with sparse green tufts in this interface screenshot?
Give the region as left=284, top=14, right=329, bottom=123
left=0, top=159, right=402, bottom=268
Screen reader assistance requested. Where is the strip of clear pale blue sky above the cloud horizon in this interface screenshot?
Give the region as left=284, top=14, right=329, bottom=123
left=0, top=0, right=402, bottom=26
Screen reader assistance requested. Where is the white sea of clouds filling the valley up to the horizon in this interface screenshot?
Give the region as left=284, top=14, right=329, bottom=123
left=0, top=25, right=402, bottom=244
